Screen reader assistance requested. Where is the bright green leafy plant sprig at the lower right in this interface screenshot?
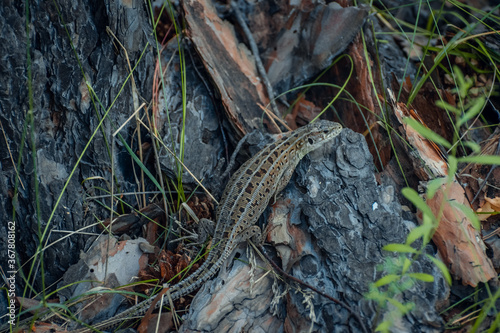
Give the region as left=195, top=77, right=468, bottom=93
left=366, top=63, right=500, bottom=332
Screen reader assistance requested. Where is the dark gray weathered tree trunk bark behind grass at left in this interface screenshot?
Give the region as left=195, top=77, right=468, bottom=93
left=0, top=0, right=154, bottom=310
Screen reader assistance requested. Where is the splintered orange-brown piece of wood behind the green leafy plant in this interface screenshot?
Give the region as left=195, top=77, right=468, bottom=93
left=389, top=90, right=496, bottom=286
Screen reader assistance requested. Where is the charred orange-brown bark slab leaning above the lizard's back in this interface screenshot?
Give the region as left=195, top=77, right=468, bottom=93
left=183, top=0, right=269, bottom=140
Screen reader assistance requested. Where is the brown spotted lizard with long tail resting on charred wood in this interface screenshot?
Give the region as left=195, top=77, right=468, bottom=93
left=7, top=120, right=342, bottom=333
